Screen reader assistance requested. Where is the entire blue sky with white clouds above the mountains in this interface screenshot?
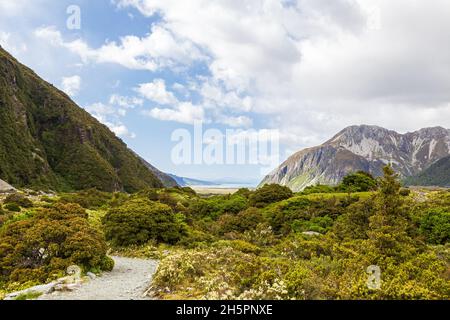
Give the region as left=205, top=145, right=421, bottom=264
left=0, top=0, right=450, bottom=182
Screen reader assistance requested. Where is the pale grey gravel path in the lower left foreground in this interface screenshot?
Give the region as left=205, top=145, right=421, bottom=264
left=39, top=257, right=158, bottom=300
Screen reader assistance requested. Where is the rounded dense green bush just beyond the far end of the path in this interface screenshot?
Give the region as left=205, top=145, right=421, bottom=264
left=102, top=198, right=185, bottom=246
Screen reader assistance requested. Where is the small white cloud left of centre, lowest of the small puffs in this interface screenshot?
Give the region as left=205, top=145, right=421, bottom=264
left=143, top=102, right=205, bottom=124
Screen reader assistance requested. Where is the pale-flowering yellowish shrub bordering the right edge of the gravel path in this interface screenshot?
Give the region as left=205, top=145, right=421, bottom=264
left=152, top=246, right=260, bottom=299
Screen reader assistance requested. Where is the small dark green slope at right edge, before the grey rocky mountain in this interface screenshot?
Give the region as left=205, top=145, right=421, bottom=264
left=405, top=156, right=450, bottom=187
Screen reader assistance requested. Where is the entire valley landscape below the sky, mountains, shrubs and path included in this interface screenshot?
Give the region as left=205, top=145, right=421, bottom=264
left=0, top=48, right=450, bottom=300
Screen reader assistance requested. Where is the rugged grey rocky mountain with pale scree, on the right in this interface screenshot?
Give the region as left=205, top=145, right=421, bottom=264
left=261, top=125, right=450, bottom=191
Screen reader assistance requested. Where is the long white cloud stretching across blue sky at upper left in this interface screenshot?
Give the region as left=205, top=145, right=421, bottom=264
left=34, top=25, right=204, bottom=71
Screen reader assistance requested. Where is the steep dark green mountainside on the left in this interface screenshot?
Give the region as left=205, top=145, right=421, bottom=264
left=0, top=47, right=162, bottom=192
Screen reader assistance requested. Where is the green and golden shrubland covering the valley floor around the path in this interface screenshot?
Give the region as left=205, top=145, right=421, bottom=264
left=0, top=167, right=450, bottom=299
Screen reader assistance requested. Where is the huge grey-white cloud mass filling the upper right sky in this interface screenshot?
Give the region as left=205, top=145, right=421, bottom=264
left=116, top=0, right=450, bottom=149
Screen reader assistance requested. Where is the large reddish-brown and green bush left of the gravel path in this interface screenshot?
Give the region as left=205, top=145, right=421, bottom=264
left=0, top=204, right=107, bottom=283
